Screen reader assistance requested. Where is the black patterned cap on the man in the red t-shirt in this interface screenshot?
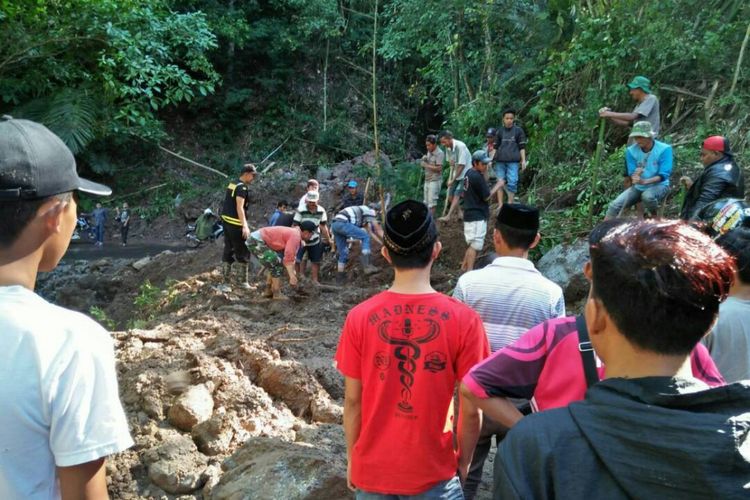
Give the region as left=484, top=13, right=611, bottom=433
left=384, top=200, right=438, bottom=255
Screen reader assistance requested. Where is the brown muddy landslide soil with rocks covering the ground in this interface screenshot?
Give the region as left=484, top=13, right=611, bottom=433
left=38, top=158, right=508, bottom=500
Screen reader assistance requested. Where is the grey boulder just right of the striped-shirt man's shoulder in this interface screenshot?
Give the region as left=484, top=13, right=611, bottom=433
left=537, top=239, right=589, bottom=305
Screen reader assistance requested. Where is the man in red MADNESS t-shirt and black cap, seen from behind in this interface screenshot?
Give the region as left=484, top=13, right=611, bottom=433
left=336, top=200, right=489, bottom=499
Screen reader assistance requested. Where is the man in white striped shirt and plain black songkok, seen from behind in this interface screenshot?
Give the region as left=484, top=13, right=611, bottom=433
left=453, top=203, right=565, bottom=499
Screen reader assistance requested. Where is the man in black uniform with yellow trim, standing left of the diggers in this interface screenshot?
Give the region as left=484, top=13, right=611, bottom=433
left=221, top=163, right=257, bottom=289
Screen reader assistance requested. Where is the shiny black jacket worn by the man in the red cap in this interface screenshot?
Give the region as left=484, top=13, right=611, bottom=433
left=680, top=155, right=745, bottom=220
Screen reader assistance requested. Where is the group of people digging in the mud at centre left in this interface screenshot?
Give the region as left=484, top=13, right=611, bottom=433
left=214, top=163, right=383, bottom=299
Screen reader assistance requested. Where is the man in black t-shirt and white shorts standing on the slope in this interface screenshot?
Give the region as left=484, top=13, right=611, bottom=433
left=461, top=149, right=492, bottom=271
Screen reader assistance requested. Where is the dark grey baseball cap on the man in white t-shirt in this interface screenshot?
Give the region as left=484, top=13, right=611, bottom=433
left=0, top=115, right=112, bottom=201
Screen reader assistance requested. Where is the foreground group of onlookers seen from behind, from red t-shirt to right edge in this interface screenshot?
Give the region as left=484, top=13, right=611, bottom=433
left=335, top=199, right=750, bottom=499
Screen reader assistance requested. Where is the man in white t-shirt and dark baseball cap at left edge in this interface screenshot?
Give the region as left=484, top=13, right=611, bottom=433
left=0, top=117, right=133, bottom=499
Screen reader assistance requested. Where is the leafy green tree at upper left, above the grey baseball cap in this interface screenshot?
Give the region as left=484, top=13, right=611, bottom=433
left=0, top=0, right=220, bottom=148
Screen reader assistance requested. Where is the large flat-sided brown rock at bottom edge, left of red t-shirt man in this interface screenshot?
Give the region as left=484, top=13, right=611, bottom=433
left=210, top=437, right=351, bottom=500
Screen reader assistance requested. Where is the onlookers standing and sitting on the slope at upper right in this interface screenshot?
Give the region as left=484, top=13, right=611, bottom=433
left=419, top=76, right=745, bottom=271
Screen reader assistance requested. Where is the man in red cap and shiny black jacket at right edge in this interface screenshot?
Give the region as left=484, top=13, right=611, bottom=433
left=680, top=135, right=745, bottom=220
